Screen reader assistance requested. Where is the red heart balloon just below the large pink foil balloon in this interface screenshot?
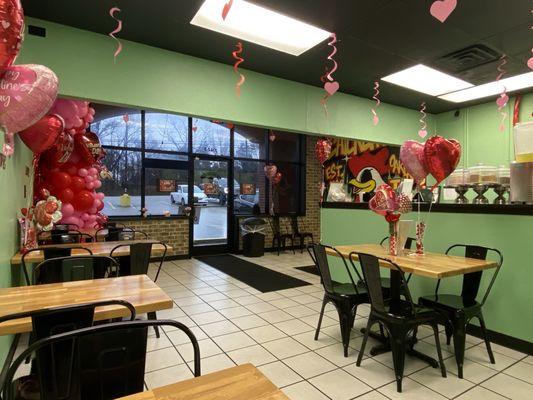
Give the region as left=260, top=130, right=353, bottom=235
left=19, top=115, right=65, bottom=154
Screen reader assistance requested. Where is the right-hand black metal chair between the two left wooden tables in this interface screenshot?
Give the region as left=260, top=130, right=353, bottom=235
left=109, top=241, right=168, bottom=338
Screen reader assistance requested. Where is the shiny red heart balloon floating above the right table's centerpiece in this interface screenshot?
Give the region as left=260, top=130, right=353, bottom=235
left=423, top=136, right=461, bottom=186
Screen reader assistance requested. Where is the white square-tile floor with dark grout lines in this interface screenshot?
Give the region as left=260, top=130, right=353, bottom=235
left=13, top=253, right=533, bottom=400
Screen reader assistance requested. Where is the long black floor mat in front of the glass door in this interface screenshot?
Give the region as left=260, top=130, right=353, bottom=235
left=195, top=254, right=311, bottom=293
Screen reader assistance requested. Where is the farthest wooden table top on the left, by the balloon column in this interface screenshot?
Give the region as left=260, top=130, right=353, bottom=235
left=11, top=240, right=172, bottom=265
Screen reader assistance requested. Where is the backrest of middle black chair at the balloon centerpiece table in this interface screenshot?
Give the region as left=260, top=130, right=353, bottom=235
left=356, top=252, right=416, bottom=314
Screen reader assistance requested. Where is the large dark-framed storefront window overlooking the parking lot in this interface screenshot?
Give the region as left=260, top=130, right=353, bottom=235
left=91, top=104, right=305, bottom=217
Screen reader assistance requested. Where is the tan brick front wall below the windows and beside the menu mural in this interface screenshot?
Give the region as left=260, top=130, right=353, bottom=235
left=113, top=136, right=322, bottom=255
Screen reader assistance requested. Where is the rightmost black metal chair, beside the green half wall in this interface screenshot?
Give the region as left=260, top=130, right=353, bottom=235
left=418, top=244, right=503, bottom=378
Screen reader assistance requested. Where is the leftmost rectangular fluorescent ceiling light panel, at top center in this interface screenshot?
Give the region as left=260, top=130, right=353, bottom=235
left=191, top=0, right=330, bottom=56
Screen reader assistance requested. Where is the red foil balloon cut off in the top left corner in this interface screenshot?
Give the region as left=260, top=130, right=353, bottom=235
left=0, top=0, right=24, bottom=75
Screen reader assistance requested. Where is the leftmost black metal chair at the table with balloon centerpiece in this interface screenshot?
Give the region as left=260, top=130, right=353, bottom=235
left=307, top=244, right=368, bottom=357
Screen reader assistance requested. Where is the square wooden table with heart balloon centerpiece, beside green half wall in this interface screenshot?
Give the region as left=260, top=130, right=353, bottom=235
left=326, top=244, right=498, bottom=368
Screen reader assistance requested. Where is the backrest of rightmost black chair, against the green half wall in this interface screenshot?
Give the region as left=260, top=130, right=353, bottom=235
left=442, top=244, right=503, bottom=305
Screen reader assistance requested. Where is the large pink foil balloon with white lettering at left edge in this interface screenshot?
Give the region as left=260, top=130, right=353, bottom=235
left=0, top=64, right=58, bottom=133
